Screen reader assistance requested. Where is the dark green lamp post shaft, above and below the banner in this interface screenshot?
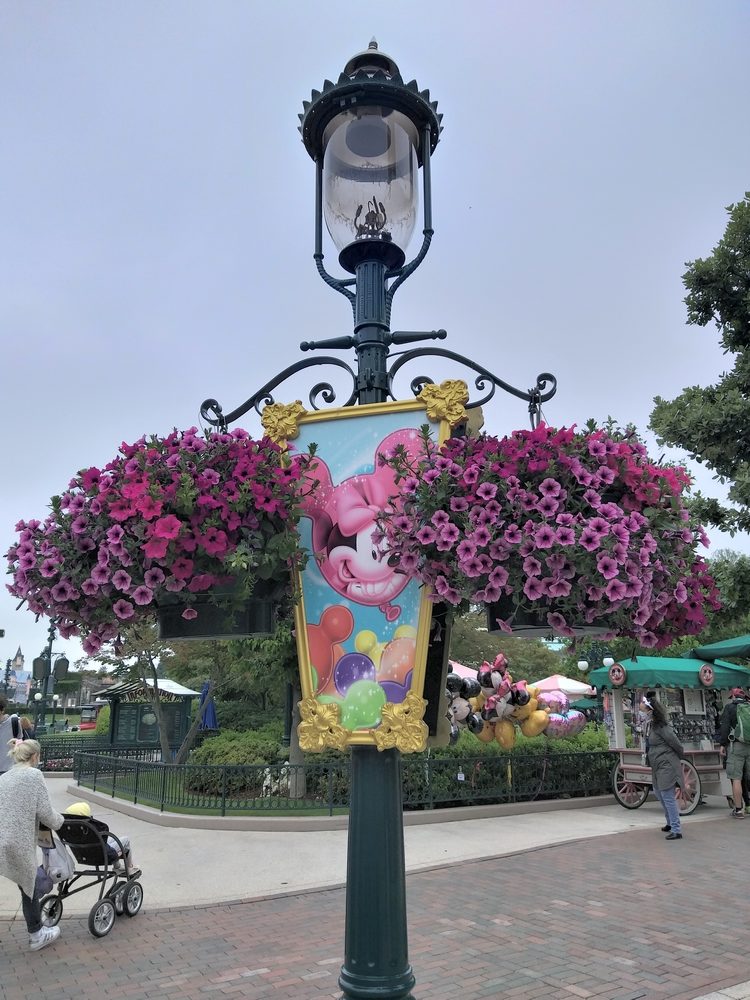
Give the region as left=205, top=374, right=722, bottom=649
left=339, top=252, right=414, bottom=1000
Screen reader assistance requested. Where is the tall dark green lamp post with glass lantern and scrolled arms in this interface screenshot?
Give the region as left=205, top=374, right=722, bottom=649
left=201, top=39, right=556, bottom=1000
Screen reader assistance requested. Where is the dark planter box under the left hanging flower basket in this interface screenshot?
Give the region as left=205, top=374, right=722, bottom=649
left=157, top=583, right=278, bottom=639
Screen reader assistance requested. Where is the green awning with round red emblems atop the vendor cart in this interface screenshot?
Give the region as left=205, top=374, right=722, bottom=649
left=587, top=656, right=750, bottom=691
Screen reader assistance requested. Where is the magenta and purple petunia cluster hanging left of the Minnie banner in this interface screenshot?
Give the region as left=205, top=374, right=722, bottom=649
left=6, top=427, right=307, bottom=655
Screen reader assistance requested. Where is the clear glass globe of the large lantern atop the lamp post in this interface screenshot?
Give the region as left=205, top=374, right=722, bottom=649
left=323, top=106, right=419, bottom=271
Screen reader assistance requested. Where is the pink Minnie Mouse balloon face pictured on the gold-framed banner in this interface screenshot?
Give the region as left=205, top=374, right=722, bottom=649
left=303, top=428, right=422, bottom=622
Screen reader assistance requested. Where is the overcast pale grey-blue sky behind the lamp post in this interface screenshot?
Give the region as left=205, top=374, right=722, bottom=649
left=0, top=0, right=750, bottom=664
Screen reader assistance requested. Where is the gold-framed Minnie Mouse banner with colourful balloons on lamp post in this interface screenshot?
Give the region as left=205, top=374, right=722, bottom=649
left=263, top=381, right=468, bottom=752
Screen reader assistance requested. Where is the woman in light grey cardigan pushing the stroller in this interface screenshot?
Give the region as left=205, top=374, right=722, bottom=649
left=0, top=739, right=64, bottom=951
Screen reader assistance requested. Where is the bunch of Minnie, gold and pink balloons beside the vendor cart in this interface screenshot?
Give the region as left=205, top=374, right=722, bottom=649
left=446, top=653, right=586, bottom=750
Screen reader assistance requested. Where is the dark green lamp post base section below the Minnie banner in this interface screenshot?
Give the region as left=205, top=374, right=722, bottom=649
left=339, top=746, right=415, bottom=1000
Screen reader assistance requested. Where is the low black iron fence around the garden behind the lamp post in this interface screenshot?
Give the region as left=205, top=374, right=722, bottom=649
left=73, top=750, right=614, bottom=816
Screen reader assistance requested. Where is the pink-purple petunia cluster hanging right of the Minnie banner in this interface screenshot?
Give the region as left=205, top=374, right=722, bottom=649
left=377, top=424, right=719, bottom=647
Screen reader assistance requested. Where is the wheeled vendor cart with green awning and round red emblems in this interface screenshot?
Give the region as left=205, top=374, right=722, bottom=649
left=589, top=656, right=750, bottom=816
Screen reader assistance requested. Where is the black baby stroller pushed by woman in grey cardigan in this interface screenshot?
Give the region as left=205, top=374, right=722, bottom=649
left=40, top=813, right=143, bottom=937
